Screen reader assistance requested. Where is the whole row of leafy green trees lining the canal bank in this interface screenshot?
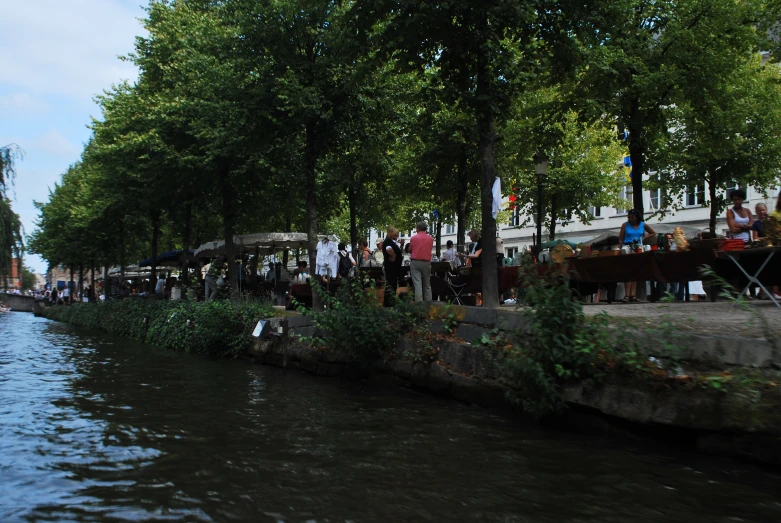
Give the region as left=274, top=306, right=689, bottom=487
left=30, top=0, right=781, bottom=306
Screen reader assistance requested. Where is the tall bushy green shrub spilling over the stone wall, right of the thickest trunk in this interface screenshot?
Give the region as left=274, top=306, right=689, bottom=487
left=501, top=266, right=620, bottom=416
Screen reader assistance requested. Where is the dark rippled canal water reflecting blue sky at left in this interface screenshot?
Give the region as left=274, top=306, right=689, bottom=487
left=0, top=313, right=781, bottom=523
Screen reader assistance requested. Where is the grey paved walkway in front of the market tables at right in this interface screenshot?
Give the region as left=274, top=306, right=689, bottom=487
left=583, top=300, right=781, bottom=338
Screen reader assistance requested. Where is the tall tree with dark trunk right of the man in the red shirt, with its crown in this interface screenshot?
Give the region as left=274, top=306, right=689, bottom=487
left=354, top=0, right=582, bottom=307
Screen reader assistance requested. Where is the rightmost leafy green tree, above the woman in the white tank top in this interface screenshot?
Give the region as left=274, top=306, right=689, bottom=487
left=660, top=55, right=781, bottom=231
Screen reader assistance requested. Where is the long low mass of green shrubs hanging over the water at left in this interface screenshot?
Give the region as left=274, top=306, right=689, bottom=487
left=46, top=300, right=273, bottom=356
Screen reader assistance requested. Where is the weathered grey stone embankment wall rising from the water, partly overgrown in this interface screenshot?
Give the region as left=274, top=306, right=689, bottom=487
left=248, top=307, right=781, bottom=464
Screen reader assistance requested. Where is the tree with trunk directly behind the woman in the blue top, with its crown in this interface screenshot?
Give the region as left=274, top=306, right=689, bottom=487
left=581, top=0, right=772, bottom=217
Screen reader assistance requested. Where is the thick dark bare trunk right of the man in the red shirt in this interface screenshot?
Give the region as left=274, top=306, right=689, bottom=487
left=476, top=39, right=499, bottom=308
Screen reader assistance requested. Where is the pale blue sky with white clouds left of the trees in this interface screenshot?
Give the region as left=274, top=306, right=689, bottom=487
left=0, top=0, right=145, bottom=273
